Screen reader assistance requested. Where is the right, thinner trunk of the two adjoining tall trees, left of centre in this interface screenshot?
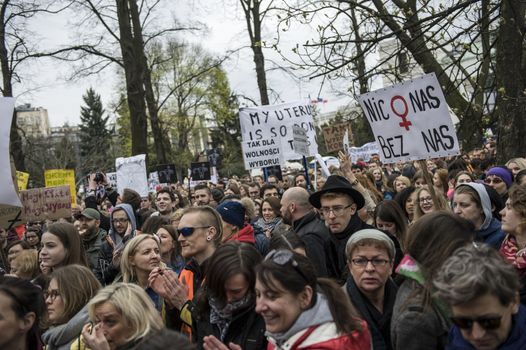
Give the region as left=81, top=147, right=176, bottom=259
left=130, top=0, right=170, bottom=164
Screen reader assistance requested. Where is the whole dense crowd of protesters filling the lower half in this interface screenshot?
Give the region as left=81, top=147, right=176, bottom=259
left=0, top=141, right=526, bottom=350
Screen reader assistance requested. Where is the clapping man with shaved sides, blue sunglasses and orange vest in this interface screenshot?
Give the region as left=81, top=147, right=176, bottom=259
left=149, top=206, right=223, bottom=335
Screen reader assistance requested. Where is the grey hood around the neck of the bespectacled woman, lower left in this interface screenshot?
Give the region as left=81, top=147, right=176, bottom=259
left=42, top=306, right=89, bottom=350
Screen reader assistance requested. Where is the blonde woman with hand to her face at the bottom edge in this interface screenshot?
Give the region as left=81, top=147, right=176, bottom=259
left=82, top=283, right=164, bottom=350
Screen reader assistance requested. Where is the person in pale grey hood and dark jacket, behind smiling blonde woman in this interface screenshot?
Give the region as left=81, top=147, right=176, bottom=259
left=93, top=203, right=137, bottom=285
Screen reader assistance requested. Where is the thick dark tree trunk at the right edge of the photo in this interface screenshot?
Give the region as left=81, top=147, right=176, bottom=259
left=495, top=0, right=526, bottom=164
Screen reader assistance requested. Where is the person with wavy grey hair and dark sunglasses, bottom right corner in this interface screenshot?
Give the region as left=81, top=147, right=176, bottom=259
left=433, top=244, right=526, bottom=350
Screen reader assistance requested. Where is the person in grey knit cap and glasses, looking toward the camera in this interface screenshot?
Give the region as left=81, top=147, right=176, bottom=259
left=343, top=229, right=398, bottom=349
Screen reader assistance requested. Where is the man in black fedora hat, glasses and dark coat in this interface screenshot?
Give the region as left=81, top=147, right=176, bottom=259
left=309, top=175, right=371, bottom=284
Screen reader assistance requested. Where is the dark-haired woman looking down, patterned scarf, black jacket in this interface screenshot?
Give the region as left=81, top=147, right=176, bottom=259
left=192, top=242, right=267, bottom=350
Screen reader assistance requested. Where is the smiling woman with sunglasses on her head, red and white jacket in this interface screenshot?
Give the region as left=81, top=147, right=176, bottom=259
left=256, top=250, right=371, bottom=350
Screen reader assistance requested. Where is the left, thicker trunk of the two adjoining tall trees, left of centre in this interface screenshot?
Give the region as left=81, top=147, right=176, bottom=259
left=116, top=0, right=148, bottom=155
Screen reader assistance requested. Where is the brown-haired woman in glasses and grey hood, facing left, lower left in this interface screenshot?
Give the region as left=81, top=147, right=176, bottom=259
left=42, top=265, right=101, bottom=350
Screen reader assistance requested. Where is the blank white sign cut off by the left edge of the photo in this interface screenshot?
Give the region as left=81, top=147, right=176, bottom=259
left=0, top=97, right=22, bottom=207
